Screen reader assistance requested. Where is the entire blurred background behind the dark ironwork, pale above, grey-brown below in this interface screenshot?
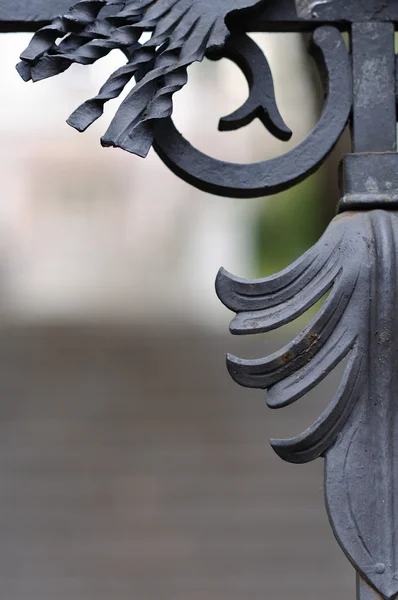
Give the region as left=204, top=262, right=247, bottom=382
left=0, top=34, right=354, bottom=600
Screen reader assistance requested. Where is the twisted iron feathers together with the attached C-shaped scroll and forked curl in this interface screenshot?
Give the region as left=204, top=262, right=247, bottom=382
left=18, top=0, right=352, bottom=202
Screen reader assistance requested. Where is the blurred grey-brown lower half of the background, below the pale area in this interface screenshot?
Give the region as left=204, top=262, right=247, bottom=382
left=0, top=327, right=354, bottom=600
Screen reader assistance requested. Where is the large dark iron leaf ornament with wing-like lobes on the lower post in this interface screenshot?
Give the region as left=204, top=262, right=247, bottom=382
left=216, top=210, right=398, bottom=598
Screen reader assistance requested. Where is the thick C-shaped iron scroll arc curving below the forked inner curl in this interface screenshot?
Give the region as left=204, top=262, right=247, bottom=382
left=154, top=26, right=352, bottom=198
